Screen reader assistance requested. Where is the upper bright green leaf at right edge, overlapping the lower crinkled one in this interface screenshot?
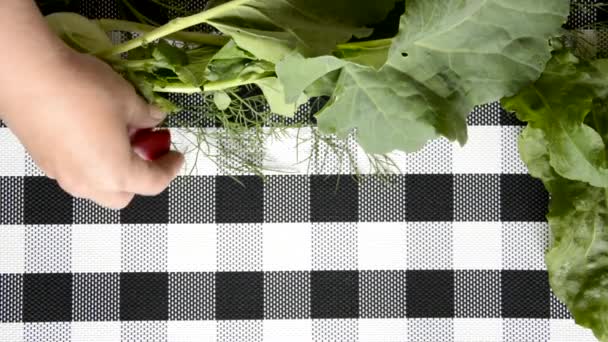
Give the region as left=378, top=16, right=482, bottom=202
left=502, top=50, right=608, bottom=187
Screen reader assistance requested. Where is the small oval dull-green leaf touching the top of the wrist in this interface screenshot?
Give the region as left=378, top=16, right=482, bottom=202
left=46, top=12, right=113, bottom=53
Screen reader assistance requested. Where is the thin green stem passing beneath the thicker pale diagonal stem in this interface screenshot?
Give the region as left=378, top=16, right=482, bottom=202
left=98, top=19, right=230, bottom=46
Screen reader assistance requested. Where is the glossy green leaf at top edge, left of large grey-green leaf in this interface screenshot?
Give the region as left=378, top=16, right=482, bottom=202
left=206, top=0, right=396, bottom=63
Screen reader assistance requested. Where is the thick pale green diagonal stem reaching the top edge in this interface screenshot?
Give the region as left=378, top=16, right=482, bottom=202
left=97, top=0, right=247, bottom=58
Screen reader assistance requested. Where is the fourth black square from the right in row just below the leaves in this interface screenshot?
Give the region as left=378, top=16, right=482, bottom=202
left=215, top=176, right=264, bottom=223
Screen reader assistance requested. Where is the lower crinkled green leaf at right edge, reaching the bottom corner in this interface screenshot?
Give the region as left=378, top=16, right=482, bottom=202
left=519, top=127, right=608, bottom=341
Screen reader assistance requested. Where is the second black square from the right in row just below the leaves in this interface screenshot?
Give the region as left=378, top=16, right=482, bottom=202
left=405, top=174, right=454, bottom=221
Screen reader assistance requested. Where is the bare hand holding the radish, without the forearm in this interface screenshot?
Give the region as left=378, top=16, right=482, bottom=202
left=3, top=52, right=183, bottom=209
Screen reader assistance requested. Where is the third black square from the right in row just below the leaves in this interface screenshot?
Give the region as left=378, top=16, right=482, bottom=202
left=310, top=175, right=359, bottom=222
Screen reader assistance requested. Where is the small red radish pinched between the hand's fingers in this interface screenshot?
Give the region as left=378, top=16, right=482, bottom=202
left=131, top=128, right=171, bottom=161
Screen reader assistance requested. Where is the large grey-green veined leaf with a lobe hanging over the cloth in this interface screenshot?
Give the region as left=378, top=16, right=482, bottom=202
left=318, top=0, right=570, bottom=154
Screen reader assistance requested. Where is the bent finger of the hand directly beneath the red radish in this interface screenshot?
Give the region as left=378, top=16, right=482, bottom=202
left=124, top=151, right=184, bottom=196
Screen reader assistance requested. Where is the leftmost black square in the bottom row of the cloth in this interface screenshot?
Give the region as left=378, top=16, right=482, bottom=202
left=23, top=273, right=72, bottom=322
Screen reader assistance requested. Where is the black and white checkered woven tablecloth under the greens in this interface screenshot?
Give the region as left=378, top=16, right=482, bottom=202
left=0, top=1, right=595, bottom=342
